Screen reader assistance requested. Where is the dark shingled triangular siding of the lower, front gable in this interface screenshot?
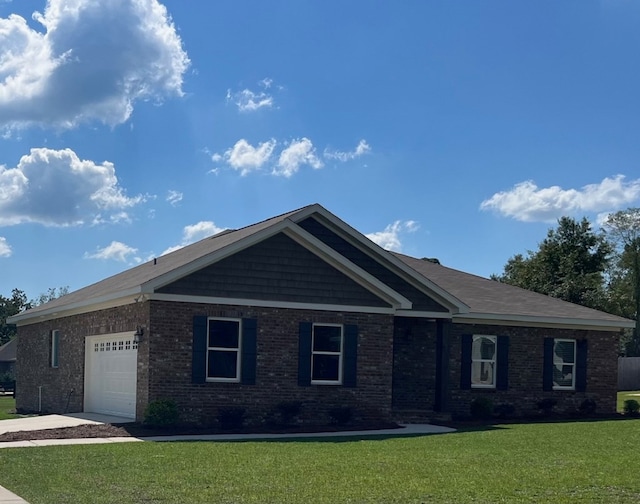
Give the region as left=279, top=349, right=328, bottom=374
left=158, top=234, right=389, bottom=307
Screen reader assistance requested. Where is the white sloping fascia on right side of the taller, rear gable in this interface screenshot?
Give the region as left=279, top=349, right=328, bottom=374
left=289, top=205, right=471, bottom=313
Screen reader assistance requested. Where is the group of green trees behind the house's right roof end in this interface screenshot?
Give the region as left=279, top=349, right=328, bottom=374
left=491, top=208, right=640, bottom=356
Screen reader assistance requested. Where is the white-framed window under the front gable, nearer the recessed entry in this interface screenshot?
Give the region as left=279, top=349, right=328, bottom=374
left=311, top=324, right=343, bottom=385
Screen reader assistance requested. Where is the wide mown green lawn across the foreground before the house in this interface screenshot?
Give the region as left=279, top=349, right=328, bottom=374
left=0, top=420, right=640, bottom=504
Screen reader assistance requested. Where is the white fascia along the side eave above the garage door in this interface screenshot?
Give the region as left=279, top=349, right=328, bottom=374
left=7, top=288, right=140, bottom=327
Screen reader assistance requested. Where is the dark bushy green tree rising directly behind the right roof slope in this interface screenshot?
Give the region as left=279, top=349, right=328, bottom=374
left=492, top=217, right=612, bottom=309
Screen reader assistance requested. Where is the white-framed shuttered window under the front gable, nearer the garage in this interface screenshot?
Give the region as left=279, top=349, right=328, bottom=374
left=207, top=319, right=241, bottom=382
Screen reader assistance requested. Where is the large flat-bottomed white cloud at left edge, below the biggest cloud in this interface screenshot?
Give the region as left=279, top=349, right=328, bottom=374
left=0, top=148, right=144, bottom=226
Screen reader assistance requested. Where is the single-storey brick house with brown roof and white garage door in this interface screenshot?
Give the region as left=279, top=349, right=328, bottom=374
left=9, top=205, right=633, bottom=422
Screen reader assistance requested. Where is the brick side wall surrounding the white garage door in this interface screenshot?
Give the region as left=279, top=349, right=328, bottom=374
left=16, top=303, right=149, bottom=418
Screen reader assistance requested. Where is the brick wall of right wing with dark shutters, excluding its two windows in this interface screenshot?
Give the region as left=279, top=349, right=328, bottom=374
left=449, top=324, right=619, bottom=415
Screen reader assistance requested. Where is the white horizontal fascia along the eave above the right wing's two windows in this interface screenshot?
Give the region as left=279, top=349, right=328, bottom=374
left=453, top=313, right=635, bottom=332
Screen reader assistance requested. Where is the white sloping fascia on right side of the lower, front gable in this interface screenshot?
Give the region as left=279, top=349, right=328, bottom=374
left=284, top=224, right=413, bottom=310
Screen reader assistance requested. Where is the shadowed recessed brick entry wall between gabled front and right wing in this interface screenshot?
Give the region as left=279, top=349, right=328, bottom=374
left=393, top=318, right=436, bottom=418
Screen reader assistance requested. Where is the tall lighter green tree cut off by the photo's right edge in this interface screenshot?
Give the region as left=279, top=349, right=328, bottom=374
left=604, top=208, right=640, bottom=356
